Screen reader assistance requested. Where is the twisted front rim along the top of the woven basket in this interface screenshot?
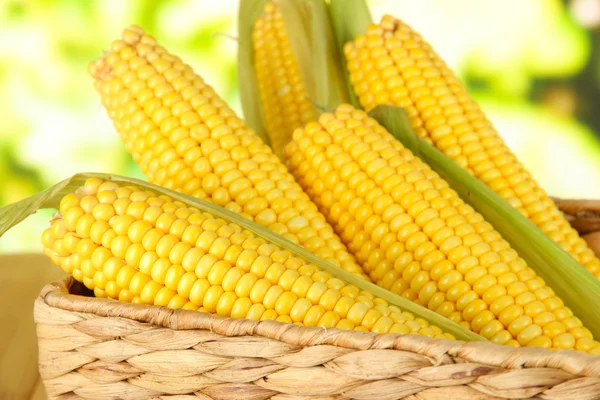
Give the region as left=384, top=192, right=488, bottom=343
left=40, top=277, right=600, bottom=377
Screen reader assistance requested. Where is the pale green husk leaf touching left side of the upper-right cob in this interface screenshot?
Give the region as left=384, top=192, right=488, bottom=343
left=329, top=0, right=373, bottom=108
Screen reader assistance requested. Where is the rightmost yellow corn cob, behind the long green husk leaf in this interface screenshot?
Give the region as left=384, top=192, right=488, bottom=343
left=344, top=16, right=600, bottom=278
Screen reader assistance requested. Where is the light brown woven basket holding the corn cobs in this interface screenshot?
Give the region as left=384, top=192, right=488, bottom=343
left=35, top=201, right=600, bottom=400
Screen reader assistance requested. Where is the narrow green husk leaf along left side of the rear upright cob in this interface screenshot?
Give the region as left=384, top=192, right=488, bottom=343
left=237, top=0, right=271, bottom=145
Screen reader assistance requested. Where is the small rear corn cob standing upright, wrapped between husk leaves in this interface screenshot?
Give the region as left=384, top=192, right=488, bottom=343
left=252, top=2, right=317, bottom=157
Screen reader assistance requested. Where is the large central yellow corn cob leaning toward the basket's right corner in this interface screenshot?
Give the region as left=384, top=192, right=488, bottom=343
left=286, top=105, right=600, bottom=352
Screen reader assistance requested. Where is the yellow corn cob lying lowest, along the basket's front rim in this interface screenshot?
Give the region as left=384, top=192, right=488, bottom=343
left=42, top=179, right=452, bottom=338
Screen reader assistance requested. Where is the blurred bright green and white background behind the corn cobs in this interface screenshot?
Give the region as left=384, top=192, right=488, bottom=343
left=0, top=0, right=600, bottom=252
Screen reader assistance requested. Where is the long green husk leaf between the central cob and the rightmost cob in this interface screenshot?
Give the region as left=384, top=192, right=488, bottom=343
left=369, top=105, right=600, bottom=338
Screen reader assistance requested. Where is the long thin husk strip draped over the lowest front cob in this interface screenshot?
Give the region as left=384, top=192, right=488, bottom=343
left=0, top=173, right=485, bottom=341
